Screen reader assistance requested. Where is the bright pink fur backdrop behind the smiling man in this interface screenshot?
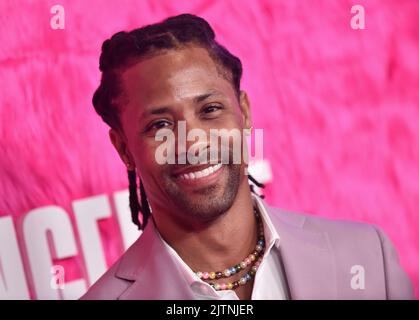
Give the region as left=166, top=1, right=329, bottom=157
left=0, top=0, right=419, bottom=299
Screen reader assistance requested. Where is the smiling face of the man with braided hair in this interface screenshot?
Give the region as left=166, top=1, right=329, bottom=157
left=113, top=47, right=250, bottom=222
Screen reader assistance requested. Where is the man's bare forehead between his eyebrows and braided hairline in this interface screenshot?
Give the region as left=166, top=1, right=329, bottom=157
left=121, top=47, right=234, bottom=107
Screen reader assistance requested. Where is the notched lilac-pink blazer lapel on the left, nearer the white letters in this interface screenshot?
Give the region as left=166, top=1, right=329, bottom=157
left=116, top=221, right=194, bottom=300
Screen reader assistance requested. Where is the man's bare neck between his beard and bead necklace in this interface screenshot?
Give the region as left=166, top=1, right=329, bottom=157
left=153, top=179, right=257, bottom=271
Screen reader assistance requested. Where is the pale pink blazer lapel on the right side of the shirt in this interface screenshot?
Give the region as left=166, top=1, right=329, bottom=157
left=268, top=207, right=337, bottom=299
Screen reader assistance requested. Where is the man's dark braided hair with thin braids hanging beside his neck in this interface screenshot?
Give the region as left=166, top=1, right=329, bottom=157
left=92, top=14, right=263, bottom=230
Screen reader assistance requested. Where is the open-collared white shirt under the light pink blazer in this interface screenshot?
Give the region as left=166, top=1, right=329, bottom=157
left=156, top=194, right=287, bottom=300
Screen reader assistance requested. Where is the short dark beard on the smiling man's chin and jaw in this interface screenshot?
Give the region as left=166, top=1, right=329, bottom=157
left=167, top=164, right=241, bottom=223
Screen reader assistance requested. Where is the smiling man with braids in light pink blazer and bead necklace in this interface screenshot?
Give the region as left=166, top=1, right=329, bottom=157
left=83, top=14, right=412, bottom=299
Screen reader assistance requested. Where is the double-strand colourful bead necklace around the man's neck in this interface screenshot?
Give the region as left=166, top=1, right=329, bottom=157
left=196, top=209, right=265, bottom=291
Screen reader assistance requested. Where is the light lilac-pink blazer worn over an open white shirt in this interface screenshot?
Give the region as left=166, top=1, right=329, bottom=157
left=82, top=204, right=413, bottom=299
